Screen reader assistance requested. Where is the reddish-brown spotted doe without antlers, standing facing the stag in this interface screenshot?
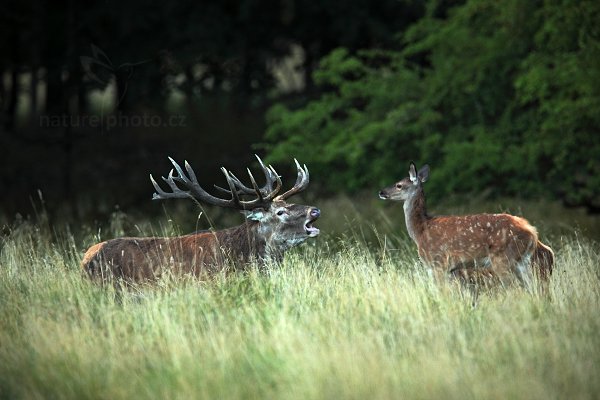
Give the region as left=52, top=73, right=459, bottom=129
left=379, top=163, right=554, bottom=288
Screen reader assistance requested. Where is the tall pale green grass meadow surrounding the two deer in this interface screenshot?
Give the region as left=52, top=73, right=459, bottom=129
left=0, top=198, right=600, bottom=399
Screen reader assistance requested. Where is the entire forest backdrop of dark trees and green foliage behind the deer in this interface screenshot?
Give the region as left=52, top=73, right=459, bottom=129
left=0, top=0, right=600, bottom=220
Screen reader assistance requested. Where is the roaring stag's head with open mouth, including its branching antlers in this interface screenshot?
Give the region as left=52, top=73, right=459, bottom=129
left=150, top=156, right=321, bottom=251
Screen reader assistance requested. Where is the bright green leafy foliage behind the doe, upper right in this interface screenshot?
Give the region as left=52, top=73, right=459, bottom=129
left=266, top=0, right=600, bottom=210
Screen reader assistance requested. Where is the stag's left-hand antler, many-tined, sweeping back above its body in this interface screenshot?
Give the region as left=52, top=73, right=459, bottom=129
left=150, top=156, right=285, bottom=210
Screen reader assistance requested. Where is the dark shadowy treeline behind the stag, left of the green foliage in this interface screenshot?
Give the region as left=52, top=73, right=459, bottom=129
left=0, top=0, right=423, bottom=219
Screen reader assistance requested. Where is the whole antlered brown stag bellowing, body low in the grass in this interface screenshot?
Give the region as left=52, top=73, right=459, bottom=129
left=81, top=156, right=320, bottom=282
